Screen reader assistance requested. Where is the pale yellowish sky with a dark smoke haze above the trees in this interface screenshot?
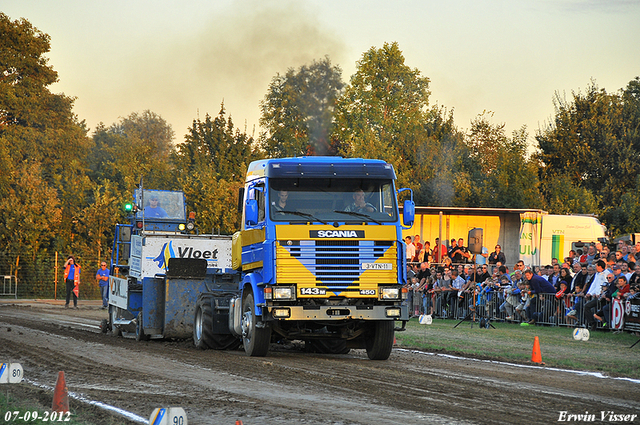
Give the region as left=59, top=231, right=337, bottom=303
left=5, top=0, right=640, bottom=147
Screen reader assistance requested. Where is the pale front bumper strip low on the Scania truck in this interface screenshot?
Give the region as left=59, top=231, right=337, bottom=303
left=263, top=305, right=409, bottom=321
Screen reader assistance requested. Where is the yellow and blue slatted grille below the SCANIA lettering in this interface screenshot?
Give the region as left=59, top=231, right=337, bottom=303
left=276, top=240, right=397, bottom=289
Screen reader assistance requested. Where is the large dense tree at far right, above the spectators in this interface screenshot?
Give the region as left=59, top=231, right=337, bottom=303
left=536, top=78, right=640, bottom=234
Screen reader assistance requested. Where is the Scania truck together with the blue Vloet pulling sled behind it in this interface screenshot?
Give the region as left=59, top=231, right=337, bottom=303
left=107, top=157, right=415, bottom=360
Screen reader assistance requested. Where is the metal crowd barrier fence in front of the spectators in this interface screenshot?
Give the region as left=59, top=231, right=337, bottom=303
left=407, top=290, right=610, bottom=328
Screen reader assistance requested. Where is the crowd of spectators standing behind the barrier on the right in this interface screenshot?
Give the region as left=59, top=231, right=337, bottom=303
left=405, top=235, right=640, bottom=329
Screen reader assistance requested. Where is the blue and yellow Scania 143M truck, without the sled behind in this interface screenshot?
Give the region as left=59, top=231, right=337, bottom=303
left=193, top=157, right=414, bottom=360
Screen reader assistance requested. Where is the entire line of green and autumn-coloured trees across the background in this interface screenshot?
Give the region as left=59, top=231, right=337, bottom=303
left=0, top=13, right=640, bottom=292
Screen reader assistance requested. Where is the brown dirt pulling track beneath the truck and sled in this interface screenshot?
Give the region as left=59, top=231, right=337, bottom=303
left=0, top=303, right=640, bottom=425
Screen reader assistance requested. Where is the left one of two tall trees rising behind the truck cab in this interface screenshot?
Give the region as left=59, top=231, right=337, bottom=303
left=260, top=57, right=344, bottom=157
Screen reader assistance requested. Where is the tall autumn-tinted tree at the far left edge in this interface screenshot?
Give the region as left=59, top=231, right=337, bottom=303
left=0, top=13, right=89, bottom=254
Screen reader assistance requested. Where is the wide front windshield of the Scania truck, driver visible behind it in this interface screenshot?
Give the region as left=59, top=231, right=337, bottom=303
left=269, top=178, right=398, bottom=223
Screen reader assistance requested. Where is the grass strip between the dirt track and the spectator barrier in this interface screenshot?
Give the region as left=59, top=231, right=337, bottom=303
left=396, top=318, right=640, bottom=379
